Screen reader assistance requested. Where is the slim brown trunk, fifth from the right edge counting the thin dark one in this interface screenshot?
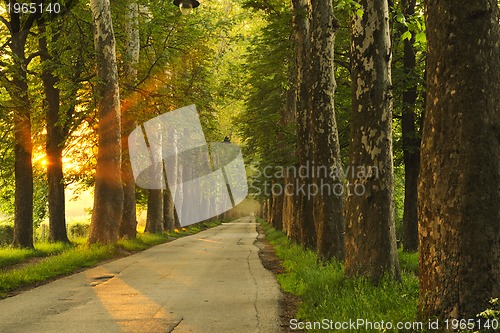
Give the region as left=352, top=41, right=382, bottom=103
left=292, top=0, right=316, bottom=248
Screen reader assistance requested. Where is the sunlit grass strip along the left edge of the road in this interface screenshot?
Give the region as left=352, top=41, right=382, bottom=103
left=0, top=222, right=220, bottom=298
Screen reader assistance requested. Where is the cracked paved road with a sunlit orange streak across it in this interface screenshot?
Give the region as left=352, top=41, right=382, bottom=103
left=0, top=217, right=280, bottom=333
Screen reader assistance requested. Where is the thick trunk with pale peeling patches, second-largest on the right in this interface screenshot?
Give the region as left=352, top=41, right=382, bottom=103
left=345, top=0, right=399, bottom=281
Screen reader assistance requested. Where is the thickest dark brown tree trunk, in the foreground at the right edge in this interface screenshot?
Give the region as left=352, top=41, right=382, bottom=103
left=418, top=0, right=500, bottom=319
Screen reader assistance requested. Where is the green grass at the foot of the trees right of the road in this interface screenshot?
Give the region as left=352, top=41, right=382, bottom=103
left=261, top=218, right=418, bottom=332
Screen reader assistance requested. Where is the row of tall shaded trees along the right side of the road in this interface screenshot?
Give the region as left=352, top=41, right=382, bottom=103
left=239, top=0, right=500, bottom=318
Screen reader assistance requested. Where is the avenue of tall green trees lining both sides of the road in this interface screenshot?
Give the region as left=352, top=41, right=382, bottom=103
left=0, top=0, right=500, bottom=319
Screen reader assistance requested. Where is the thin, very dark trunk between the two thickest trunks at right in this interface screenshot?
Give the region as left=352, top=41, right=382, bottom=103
left=401, top=0, right=420, bottom=252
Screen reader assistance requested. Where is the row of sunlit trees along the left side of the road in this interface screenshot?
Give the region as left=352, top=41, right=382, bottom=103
left=0, top=0, right=246, bottom=247
